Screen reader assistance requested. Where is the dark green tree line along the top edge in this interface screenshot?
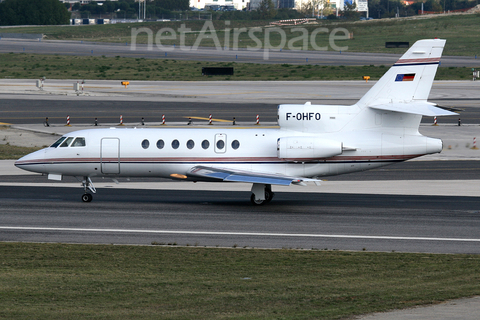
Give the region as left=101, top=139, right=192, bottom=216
left=0, top=0, right=478, bottom=25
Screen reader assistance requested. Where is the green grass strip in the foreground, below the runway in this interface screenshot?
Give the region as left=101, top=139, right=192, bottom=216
left=0, top=243, right=480, bottom=319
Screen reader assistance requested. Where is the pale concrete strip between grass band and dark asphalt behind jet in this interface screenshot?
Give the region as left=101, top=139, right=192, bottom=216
left=0, top=79, right=480, bottom=106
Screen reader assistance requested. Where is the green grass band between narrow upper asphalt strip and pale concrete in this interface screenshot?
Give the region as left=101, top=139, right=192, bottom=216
left=0, top=53, right=480, bottom=81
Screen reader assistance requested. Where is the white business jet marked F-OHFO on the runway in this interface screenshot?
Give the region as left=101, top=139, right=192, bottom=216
left=15, top=39, right=456, bottom=205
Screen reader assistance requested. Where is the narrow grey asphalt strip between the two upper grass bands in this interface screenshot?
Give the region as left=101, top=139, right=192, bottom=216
left=0, top=38, right=480, bottom=68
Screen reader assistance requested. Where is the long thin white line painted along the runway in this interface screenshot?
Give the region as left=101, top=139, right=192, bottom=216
left=0, top=226, right=480, bottom=242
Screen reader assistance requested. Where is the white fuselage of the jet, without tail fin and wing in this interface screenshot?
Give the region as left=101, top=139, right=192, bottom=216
left=16, top=106, right=442, bottom=180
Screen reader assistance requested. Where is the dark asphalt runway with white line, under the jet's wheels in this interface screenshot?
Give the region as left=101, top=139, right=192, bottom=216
left=0, top=187, right=480, bottom=253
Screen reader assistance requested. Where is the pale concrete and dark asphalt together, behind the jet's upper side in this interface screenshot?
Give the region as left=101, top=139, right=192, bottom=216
left=0, top=80, right=480, bottom=124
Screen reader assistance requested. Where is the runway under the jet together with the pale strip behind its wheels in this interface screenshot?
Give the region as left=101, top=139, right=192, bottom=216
left=0, top=161, right=480, bottom=253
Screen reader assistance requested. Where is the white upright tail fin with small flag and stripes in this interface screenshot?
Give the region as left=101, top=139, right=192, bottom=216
left=357, top=39, right=446, bottom=109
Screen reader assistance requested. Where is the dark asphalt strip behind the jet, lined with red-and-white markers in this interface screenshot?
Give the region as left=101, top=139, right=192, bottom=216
left=0, top=99, right=480, bottom=125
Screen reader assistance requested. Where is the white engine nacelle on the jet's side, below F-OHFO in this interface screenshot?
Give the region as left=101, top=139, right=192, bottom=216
left=277, top=136, right=343, bottom=161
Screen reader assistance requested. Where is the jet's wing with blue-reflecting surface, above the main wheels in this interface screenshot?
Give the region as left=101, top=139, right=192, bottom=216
left=187, top=166, right=311, bottom=186
